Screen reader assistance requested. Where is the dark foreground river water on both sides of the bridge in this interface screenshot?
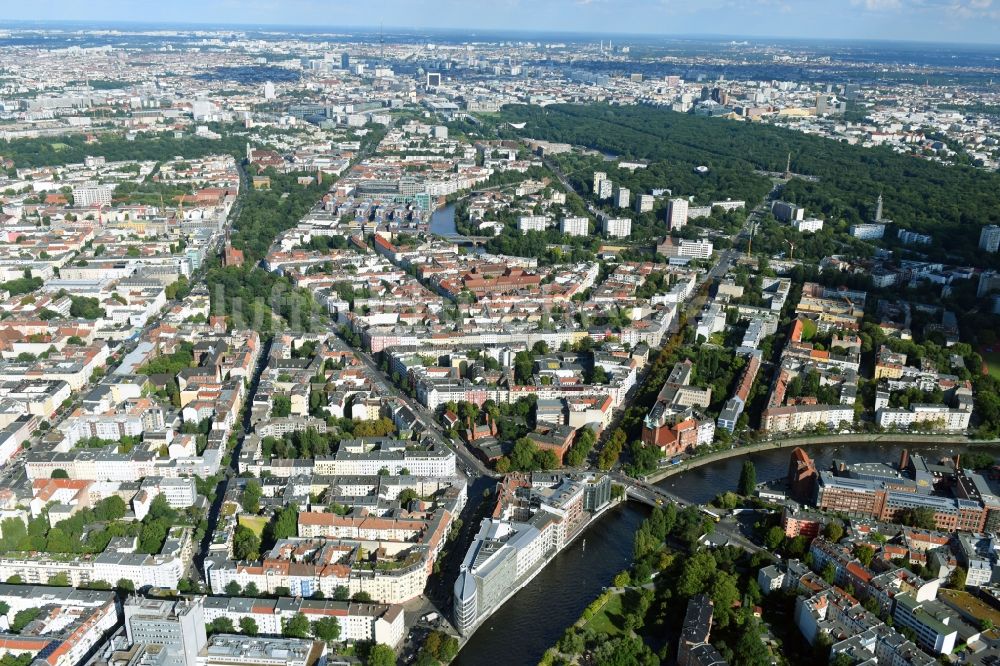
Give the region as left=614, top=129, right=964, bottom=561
left=453, top=444, right=965, bottom=666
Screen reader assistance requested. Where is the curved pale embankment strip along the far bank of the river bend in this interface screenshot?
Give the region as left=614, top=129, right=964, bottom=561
left=645, top=433, right=1000, bottom=483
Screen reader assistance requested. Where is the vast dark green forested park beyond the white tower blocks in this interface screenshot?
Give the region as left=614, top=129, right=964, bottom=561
left=458, top=104, right=1000, bottom=268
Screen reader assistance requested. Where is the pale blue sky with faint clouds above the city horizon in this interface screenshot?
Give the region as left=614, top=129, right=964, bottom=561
left=0, top=0, right=1000, bottom=44
